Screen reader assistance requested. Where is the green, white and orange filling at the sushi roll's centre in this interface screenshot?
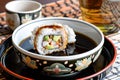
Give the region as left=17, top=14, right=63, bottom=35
left=42, top=35, right=63, bottom=50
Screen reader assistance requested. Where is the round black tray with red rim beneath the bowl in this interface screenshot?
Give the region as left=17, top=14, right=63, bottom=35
left=0, top=37, right=116, bottom=80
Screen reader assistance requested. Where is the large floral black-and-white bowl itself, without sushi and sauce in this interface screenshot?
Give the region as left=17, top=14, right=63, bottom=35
left=12, top=17, right=104, bottom=75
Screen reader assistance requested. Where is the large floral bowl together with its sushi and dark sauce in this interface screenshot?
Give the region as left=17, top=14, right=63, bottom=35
left=12, top=17, right=104, bottom=77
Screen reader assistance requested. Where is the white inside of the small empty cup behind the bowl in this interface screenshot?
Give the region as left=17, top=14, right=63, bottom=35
left=5, top=1, right=42, bottom=13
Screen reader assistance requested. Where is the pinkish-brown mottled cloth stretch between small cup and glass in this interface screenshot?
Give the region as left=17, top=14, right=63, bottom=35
left=42, top=0, right=81, bottom=18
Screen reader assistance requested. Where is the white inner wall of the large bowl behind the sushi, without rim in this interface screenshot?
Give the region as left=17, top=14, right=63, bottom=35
left=14, top=19, right=102, bottom=45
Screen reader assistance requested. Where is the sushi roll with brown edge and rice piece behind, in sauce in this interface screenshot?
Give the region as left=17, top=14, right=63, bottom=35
left=32, top=23, right=76, bottom=55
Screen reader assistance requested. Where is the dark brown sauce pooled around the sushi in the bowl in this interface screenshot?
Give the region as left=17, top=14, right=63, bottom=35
left=20, top=33, right=97, bottom=56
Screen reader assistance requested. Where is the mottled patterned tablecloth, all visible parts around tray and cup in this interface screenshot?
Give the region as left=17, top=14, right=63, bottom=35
left=0, top=0, right=120, bottom=80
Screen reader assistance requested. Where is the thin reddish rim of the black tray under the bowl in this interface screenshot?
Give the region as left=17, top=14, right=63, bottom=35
left=0, top=36, right=117, bottom=80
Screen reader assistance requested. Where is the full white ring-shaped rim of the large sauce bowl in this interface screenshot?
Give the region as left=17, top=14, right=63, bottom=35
left=12, top=17, right=104, bottom=61
